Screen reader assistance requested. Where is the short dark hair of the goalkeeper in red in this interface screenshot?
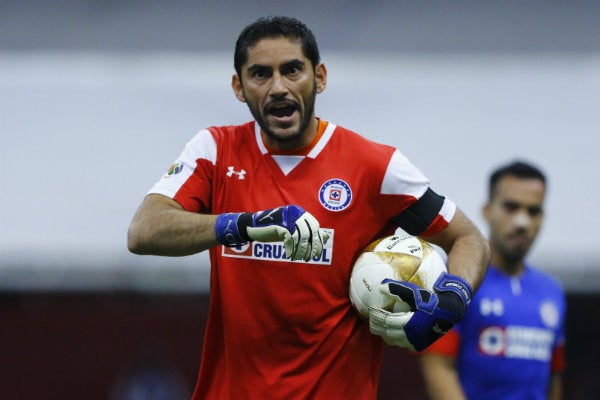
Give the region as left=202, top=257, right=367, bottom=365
left=233, top=16, right=321, bottom=79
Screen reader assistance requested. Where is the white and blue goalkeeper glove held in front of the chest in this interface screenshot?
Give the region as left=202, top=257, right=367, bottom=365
left=215, top=205, right=329, bottom=261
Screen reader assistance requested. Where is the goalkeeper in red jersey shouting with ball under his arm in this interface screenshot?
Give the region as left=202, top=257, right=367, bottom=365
left=128, top=17, right=489, bottom=400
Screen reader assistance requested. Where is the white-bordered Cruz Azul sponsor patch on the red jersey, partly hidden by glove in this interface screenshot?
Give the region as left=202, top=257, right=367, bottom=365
left=221, top=228, right=333, bottom=265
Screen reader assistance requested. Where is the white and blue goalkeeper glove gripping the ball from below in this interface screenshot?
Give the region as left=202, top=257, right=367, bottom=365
left=369, top=272, right=473, bottom=351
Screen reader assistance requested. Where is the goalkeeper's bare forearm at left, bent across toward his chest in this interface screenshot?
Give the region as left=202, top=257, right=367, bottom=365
left=127, top=196, right=217, bottom=256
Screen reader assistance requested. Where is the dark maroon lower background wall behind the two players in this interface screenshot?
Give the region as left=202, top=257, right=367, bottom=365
left=0, top=293, right=600, bottom=400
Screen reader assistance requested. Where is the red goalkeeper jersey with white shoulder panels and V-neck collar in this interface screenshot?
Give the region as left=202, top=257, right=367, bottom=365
left=150, top=121, right=455, bottom=400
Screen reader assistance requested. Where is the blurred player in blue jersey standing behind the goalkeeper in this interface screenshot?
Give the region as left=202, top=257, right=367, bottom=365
left=421, top=162, right=565, bottom=400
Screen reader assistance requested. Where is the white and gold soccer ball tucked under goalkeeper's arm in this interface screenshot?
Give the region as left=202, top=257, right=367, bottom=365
left=350, top=234, right=447, bottom=317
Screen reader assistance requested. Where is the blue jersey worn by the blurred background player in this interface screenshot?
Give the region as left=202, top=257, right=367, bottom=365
left=432, top=266, right=566, bottom=400
